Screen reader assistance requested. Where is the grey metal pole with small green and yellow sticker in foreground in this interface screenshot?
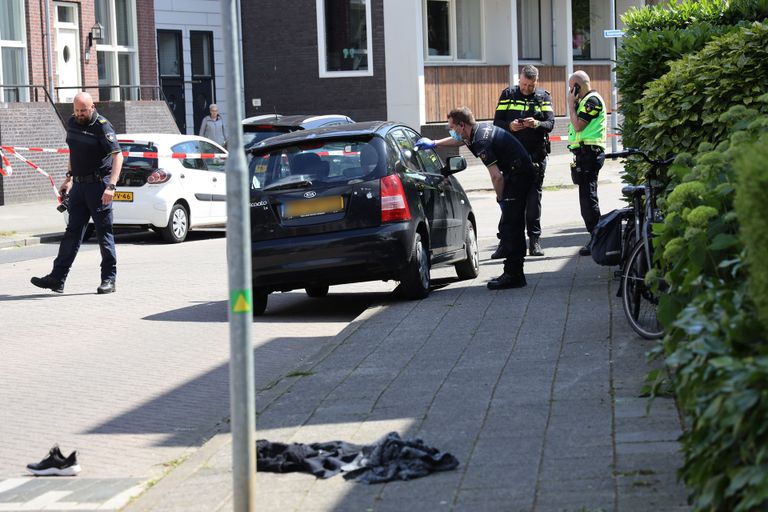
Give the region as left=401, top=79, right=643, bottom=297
left=221, top=0, right=256, bottom=512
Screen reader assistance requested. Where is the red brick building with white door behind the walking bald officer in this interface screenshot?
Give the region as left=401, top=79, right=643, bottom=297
left=0, top=0, right=175, bottom=206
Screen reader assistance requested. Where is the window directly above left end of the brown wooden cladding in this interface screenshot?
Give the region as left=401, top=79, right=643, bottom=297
left=423, top=0, right=483, bottom=61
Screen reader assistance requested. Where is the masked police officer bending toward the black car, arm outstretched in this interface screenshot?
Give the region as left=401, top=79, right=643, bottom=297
left=416, top=107, right=536, bottom=290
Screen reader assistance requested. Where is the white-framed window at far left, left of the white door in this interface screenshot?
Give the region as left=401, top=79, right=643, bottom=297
left=0, top=0, right=29, bottom=102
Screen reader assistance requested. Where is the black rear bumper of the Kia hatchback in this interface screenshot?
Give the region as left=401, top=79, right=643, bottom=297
left=251, top=222, right=415, bottom=291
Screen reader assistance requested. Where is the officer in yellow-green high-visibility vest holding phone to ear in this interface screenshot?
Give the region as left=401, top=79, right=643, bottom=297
left=568, top=71, right=607, bottom=256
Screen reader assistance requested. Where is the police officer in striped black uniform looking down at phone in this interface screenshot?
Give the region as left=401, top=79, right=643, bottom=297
left=491, top=65, right=555, bottom=259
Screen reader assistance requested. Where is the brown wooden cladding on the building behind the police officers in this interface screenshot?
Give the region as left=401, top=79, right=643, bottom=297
left=424, top=64, right=611, bottom=123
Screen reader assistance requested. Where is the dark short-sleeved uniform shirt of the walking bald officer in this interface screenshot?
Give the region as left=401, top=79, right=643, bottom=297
left=67, top=111, right=121, bottom=176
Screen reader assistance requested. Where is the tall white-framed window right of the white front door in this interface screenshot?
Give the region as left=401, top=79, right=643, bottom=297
left=95, top=0, right=139, bottom=101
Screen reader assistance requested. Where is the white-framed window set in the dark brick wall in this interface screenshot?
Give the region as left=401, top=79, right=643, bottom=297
left=316, top=0, right=373, bottom=77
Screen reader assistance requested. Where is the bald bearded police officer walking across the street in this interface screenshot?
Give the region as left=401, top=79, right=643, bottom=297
left=32, top=92, right=123, bottom=293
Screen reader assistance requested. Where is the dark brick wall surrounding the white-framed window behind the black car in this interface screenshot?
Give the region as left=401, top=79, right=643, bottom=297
left=242, top=0, right=387, bottom=121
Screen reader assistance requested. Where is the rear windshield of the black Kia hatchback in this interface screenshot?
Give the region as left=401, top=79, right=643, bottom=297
left=248, top=137, right=386, bottom=191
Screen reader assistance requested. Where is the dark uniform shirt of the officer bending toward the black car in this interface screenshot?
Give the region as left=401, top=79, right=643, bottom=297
left=468, top=123, right=533, bottom=175
